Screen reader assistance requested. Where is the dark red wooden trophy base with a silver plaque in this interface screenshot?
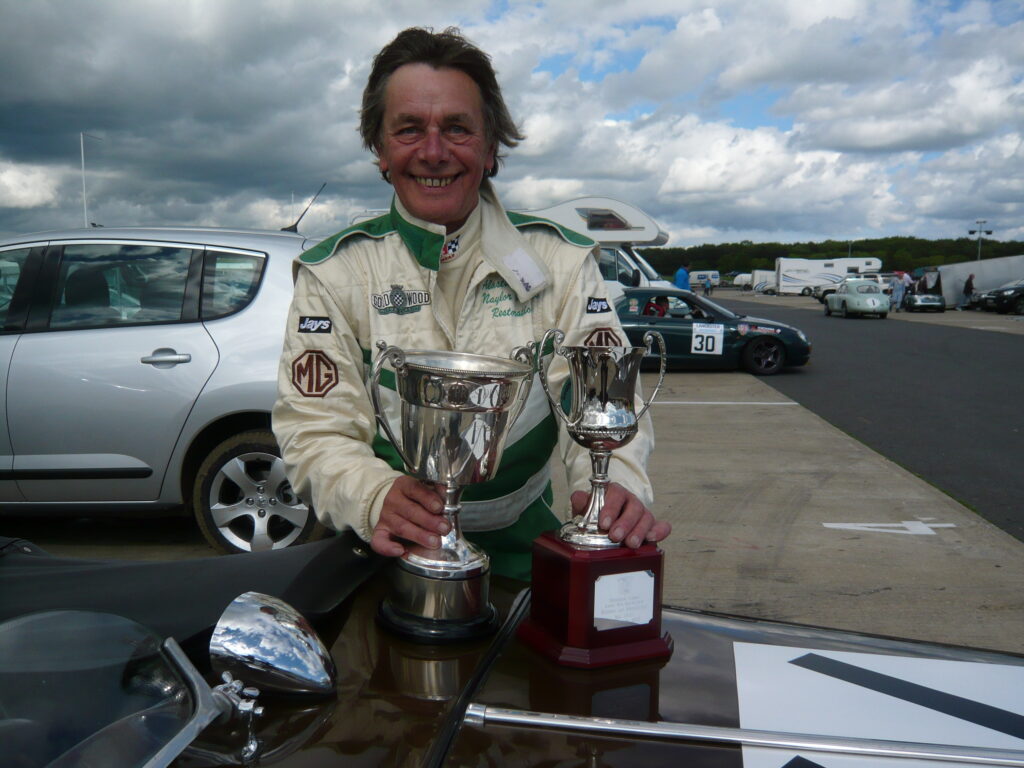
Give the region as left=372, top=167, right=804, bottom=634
left=518, top=531, right=672, bottom=669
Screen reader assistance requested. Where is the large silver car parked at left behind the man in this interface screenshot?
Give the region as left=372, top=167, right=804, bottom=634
left=0, top=228, right=325, bottom=552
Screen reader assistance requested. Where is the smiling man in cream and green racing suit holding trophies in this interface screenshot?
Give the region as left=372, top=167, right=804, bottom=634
left=273, top=29, right=671, bottom=579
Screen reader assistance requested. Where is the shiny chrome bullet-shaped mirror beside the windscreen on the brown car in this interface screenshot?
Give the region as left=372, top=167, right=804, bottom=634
left=210, top=592, right=338, bottom=695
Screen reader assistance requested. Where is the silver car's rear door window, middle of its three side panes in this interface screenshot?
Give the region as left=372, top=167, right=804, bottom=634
left=50, top=243, right=194, bottom=330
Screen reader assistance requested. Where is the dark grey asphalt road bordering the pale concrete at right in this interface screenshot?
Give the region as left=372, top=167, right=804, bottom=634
left=715, top=292, right=1024, bottom=541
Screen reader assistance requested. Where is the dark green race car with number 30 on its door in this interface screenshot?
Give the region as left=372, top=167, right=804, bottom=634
left=615, top=288, right=811, bottom=376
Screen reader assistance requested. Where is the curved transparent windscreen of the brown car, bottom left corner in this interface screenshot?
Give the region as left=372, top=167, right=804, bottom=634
left=0, top=610, right=195, bottom=766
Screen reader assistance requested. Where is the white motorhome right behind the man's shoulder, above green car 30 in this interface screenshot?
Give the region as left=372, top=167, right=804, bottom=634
left=520, top=198, right=674, bottom=301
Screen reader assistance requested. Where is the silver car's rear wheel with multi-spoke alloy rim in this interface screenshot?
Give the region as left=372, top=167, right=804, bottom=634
left=193, top=429, right=328, bottom=554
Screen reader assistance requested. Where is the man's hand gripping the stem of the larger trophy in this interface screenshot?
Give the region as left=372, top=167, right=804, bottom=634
left=370, top=475, right=451, bottom=557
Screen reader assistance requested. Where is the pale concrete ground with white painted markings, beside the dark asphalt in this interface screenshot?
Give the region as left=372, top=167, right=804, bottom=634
left=6, top=292, right=1024, bottom=653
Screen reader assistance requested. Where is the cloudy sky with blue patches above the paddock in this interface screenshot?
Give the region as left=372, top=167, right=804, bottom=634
left=0, top=0, right=1024, bottom=246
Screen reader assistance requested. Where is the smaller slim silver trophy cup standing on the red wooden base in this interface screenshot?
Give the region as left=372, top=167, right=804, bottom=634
left=540, top=329, right=667, bottom=549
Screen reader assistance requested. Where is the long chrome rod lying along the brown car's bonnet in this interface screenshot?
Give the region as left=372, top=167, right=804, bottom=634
left=466, top=703, right=1024, bottom=768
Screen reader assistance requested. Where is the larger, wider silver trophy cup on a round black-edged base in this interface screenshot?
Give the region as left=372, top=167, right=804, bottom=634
left=370, top=341, right=536, bottom=639
